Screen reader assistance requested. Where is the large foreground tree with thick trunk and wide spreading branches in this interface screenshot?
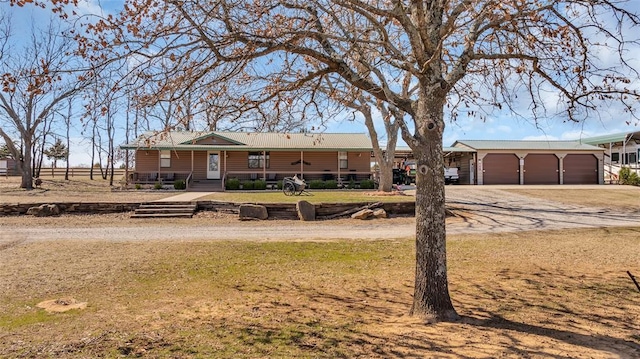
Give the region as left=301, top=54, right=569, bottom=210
left=82, top=0, right=640, bottom=320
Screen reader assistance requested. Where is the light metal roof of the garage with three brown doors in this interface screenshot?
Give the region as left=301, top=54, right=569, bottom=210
left=452, top=140, right=602, bottom=151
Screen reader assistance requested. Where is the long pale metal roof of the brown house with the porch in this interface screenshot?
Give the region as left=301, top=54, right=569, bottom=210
left=120, top=131, right=372, bottom=151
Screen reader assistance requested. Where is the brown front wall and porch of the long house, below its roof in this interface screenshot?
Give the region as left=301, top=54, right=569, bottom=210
left=128, top=149, right=373, bottom=190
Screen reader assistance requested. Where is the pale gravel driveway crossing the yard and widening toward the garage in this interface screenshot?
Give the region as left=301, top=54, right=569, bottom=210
left=0, top=186, right=640, bottom=246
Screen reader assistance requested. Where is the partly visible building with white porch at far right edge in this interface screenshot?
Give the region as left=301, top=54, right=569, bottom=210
left=581, top=131, right=640, bottom=180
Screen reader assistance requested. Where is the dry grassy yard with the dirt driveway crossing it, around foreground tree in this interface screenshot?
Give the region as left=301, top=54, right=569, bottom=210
left=0, top=179, right=640, bottom=358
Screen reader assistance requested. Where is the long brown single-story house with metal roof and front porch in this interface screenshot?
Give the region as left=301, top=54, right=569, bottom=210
left=120, top=131, right=372, bottom=188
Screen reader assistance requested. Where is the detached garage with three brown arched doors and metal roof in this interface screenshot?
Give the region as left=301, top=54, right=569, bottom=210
left=395, top=140, right=605, bottom=185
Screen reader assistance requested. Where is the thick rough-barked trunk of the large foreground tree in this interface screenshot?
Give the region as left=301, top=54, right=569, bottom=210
left=411, top=96, right=459, bottom=321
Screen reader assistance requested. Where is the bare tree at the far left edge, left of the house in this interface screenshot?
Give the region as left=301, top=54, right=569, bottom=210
left=0, top=14, right=90, bottom=189
